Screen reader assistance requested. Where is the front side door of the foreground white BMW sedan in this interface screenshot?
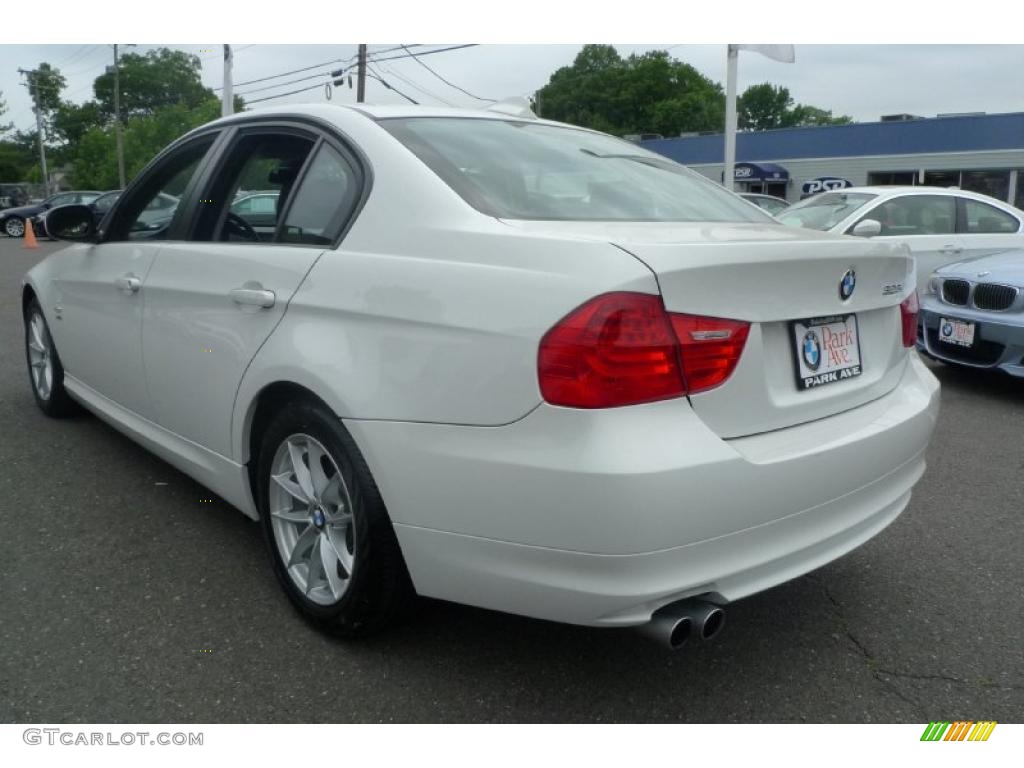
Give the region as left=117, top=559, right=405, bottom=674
left=52, top=134, right=215, bottom=418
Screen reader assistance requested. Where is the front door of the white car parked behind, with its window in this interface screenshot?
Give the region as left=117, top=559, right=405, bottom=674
left=846, top=194, right=963, bottom=292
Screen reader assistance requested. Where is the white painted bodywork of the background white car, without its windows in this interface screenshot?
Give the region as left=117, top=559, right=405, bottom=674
left=779, top=186, right=1024, bottom=293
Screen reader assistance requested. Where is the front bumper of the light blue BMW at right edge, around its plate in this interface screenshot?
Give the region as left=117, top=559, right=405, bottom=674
left=918, top=297, right=1024, bottom=377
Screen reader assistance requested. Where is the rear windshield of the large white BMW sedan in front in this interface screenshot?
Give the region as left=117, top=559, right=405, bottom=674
left=381, top=118, right=773, bottom=223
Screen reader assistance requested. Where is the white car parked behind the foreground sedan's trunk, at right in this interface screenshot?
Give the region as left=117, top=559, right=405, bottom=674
left=778, top=186, right=1024, bottom=292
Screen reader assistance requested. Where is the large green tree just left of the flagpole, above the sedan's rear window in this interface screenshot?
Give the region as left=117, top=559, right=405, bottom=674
left=535, top=45, right=725, bottom=135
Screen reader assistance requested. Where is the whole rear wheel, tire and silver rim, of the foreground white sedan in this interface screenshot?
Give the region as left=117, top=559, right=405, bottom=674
left=256, top=401, right=413, bottom=637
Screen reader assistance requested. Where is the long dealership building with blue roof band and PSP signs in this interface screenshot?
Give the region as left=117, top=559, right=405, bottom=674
left=641, top=113, right=1024, bottom=208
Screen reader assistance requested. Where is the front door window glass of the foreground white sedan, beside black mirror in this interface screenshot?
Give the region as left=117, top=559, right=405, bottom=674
left=105, top=136, right=214, bottom=241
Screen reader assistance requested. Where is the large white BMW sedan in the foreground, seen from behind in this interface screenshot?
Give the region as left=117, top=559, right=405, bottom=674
left=23, top=105, right=939, bottom=647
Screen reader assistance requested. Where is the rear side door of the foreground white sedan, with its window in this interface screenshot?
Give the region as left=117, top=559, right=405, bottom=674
left=142, top=125, right=362, bottom=457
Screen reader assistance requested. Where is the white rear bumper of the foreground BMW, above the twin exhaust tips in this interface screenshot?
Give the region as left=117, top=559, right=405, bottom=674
left=347, top=355, right=939, bottom=626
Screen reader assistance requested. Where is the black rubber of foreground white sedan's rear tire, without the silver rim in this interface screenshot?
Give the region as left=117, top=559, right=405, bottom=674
left=256, top=400, right=414, bottom=637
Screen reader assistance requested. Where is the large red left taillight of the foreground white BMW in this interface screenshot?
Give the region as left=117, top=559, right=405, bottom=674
left=538, top=293, right=750, bottom=408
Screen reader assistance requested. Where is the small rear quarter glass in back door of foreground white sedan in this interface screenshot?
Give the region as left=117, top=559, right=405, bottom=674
left=281, top=143, right=358, bottom=245
